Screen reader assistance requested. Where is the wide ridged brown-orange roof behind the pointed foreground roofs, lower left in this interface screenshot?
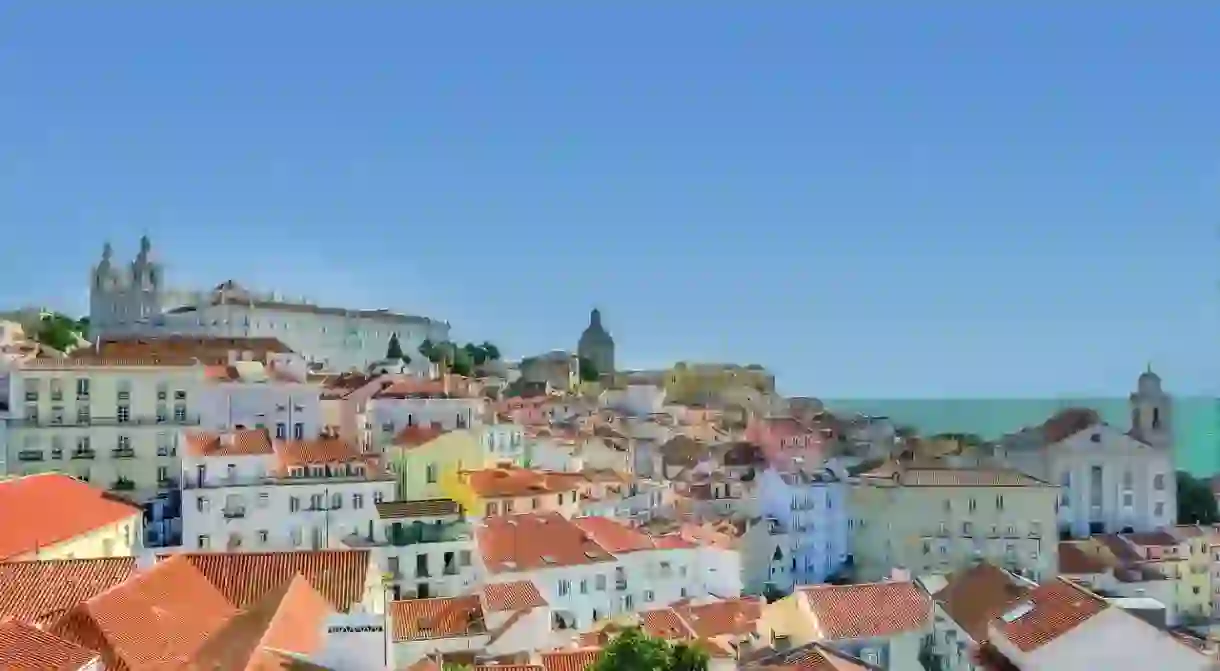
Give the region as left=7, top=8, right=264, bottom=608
left=166, top=550, right=370, bottom=612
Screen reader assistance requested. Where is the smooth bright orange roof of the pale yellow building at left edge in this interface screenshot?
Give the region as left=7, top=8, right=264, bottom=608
left=0, top=473, right=142, bottom=560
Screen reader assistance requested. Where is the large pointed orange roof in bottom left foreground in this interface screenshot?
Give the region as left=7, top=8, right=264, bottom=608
left=50, top=556, right=237, bottom=670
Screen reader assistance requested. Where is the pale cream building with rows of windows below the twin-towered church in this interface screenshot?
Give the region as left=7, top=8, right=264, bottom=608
left=6, top=356, right=205, bottom=500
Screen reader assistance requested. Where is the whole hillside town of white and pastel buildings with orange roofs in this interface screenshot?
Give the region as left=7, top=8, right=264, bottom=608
left=0, top=238, right=1220, bottom=671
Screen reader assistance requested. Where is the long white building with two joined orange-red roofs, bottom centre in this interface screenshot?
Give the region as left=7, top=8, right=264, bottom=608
left=476, top=512, right=722, bottom=631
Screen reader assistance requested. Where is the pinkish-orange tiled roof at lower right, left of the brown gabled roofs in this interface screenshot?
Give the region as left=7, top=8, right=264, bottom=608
left=799, top=581, right=932, bottom=641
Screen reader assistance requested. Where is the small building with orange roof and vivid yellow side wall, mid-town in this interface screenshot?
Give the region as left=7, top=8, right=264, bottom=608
left=444, top=467, right=589, bottom=519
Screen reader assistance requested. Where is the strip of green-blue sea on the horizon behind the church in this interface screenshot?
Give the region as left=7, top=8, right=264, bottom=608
left=825, top=397, right=1220, bottom=476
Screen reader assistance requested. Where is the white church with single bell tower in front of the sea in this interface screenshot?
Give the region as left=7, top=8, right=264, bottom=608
left=999, top=371, right=1177, bottom=538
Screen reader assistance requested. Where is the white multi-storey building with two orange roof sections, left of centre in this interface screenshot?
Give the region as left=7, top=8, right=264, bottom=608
left=182, top=429, right=394, bottom=551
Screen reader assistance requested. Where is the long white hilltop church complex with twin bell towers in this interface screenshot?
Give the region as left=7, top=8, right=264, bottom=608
left=89, top=237, right=449, bottom=372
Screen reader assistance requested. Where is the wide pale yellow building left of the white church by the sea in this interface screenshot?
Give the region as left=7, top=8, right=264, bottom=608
left=848, top=461, right=1058, bottom=580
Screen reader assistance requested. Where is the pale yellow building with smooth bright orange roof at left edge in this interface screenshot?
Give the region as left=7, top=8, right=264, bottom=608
left=0, top=473, right=144, bottom=561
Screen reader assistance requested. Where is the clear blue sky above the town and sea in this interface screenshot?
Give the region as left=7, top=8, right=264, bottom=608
left=0, top=0, right=1220, bottom=397
